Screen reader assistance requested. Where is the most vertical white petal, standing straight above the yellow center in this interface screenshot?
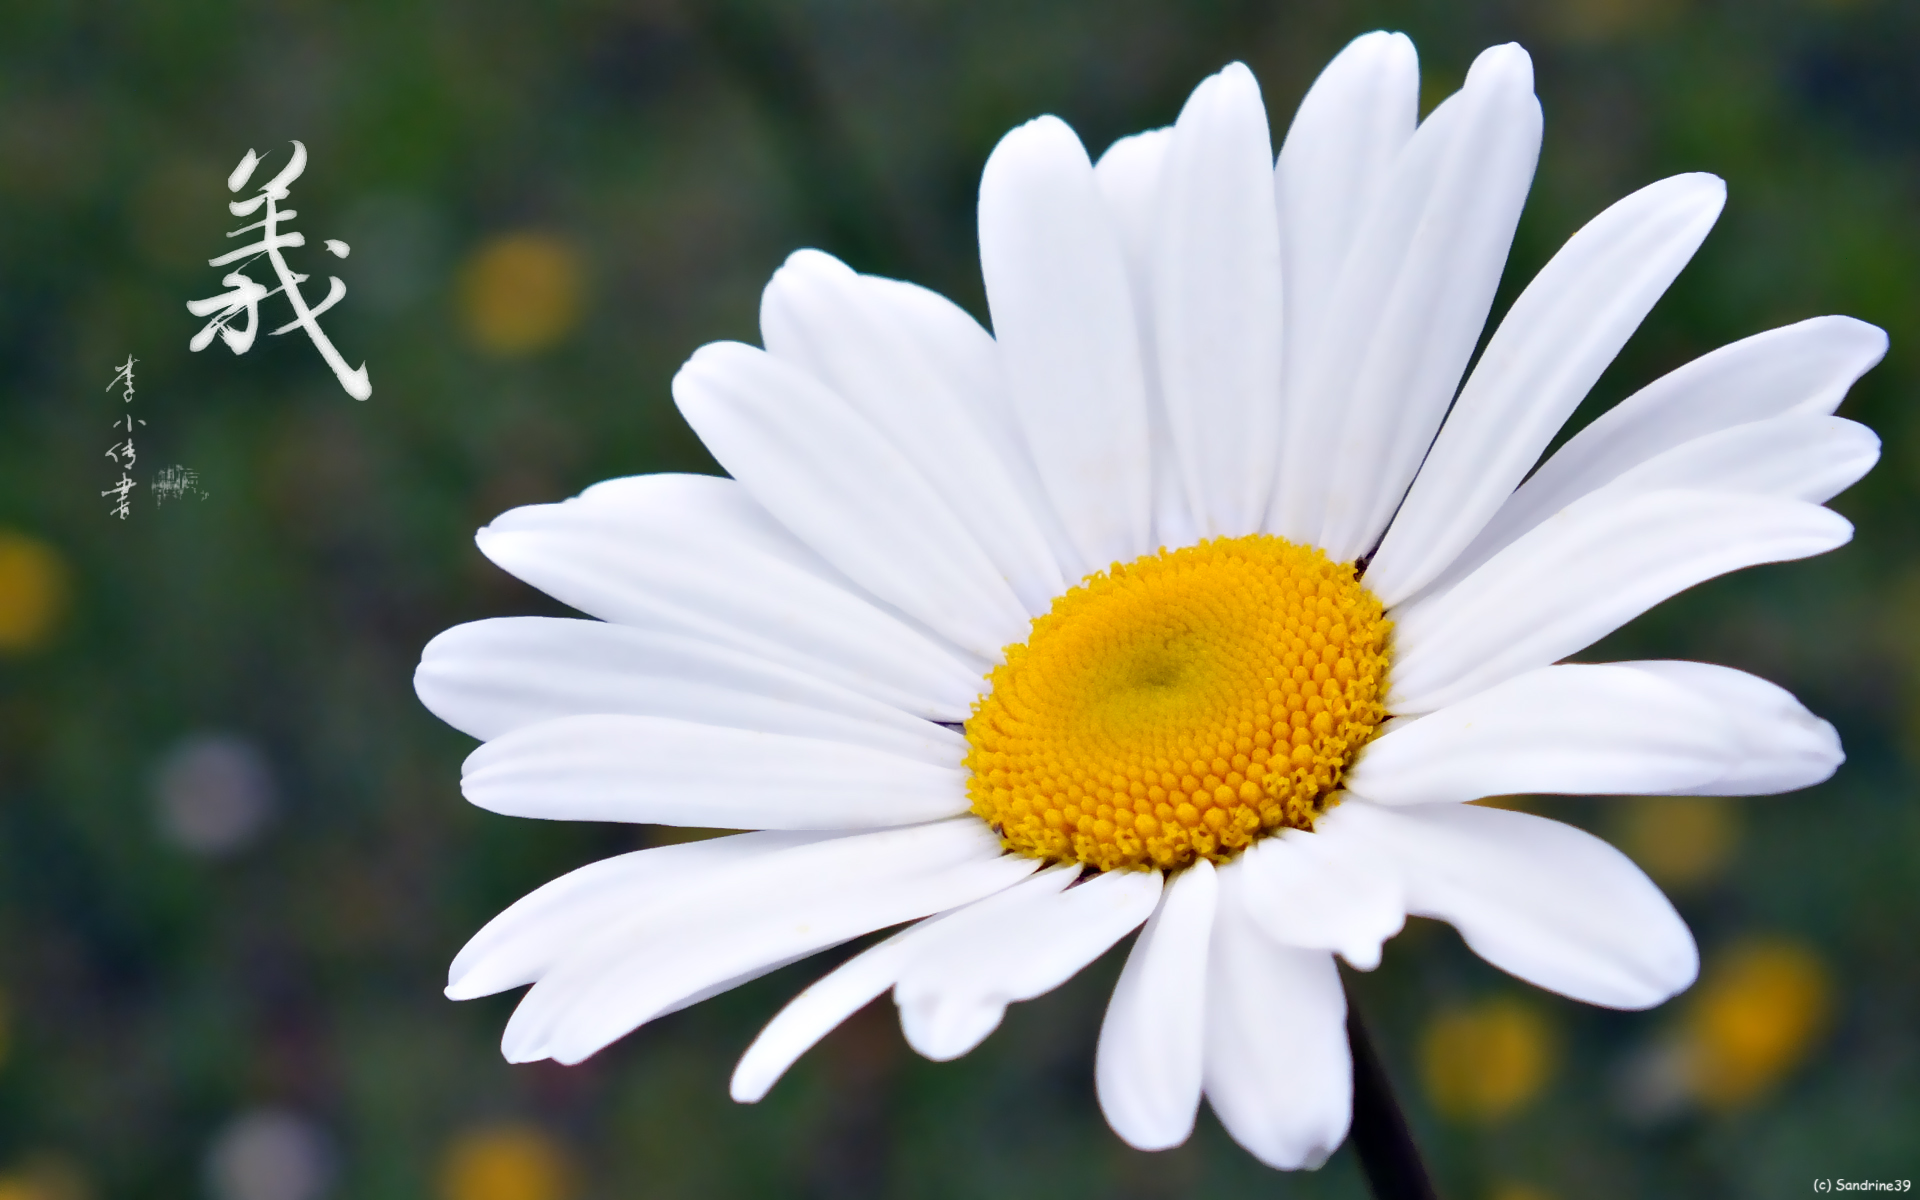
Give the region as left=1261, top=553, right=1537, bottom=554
left=1150, top=63, right=1281, bottom=538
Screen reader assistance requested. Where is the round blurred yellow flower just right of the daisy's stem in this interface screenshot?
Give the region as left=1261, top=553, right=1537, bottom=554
left=1421, top=996, right=1559, bottom=1121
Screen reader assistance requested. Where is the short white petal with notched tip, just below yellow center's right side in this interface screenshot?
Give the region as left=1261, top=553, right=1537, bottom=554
left=1240, top=804, right=1407, bottom=972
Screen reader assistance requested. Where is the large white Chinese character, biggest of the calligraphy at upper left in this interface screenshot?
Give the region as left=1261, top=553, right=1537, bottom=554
left=186, top=142, right=372, bottom=399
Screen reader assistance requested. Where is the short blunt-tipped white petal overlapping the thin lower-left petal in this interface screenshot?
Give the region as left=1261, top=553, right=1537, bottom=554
left=893, top=864, right=1162, bottom=1062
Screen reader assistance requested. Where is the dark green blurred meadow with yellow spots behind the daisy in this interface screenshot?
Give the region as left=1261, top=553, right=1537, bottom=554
left=0, top=0, right=1920, bottom=1200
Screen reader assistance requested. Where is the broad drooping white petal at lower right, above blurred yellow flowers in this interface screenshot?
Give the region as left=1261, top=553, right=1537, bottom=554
left=1379, top=804, right=1699, bottom=1008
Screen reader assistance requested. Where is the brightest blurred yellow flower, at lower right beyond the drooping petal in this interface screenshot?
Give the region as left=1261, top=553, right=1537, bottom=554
left=1682, top=937, right=1834, bottom=1108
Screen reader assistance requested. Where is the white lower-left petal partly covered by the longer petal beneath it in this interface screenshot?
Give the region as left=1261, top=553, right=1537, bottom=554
left=447, top=833, right=828, bottom=1000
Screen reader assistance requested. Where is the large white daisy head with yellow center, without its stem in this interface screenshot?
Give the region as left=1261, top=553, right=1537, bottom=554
left=417, top=33, right=1885, bottom=1167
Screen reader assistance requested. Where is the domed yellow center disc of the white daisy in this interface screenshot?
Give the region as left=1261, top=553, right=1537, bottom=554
left=966, top=534, right=1390, bottom=870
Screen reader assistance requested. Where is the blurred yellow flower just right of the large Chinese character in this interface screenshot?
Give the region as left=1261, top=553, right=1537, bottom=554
left=459, top=230, right=582, bottom=357
